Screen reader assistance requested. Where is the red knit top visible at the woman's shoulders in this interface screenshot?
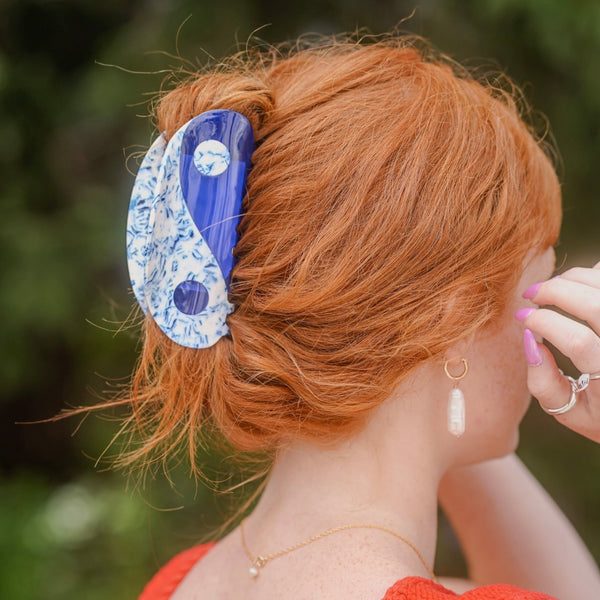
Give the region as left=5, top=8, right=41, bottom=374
left=138, top=544, right=554, bottom=600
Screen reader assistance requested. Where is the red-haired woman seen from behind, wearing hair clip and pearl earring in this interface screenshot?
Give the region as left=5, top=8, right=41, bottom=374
left=125, top=38, right=600, bottom=600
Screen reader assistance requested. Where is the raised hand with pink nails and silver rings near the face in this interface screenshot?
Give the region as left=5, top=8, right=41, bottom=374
left=515, top=263, right=600, bottom=443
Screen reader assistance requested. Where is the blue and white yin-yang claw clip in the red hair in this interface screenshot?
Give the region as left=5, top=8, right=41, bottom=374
left=127, top=110, right=255, bottom=348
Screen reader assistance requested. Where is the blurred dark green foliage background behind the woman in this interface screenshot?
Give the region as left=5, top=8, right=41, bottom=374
left=0, top=0, right=600, bottom=600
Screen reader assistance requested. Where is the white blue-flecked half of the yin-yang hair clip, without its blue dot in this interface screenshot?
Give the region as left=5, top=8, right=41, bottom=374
left=127, top=123, right=233, bottom=348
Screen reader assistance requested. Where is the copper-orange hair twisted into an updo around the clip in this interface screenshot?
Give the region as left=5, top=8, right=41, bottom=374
left=122, top=36, right=561, bottom=474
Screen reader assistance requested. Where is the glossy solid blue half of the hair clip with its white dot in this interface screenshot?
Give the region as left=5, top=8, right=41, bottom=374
left=179, top=110, right=255, bottom=287
